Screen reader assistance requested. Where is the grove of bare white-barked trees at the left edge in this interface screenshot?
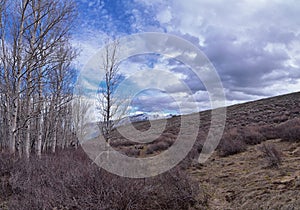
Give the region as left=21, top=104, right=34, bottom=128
left=0, top=0, right=77, bottom=157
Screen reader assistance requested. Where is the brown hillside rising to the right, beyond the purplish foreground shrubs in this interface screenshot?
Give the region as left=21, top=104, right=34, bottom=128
left=109, top=92, right=300, bottom=209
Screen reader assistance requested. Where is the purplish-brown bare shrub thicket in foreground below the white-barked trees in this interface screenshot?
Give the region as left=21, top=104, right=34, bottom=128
left=0, top=150, right=203, bottom=209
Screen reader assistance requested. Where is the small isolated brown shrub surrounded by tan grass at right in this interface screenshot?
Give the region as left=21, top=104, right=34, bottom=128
left=259, top=144, right=282, bottom=168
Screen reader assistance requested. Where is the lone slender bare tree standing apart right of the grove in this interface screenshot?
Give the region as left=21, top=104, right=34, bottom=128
left=98, top=40, right=128, bottom=142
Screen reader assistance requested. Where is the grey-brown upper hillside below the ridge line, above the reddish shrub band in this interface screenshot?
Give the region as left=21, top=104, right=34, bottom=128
left=111, top=92, right=300, bottom=156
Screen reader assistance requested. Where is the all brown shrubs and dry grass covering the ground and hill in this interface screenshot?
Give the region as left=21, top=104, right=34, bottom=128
left=0, top=93, right=300, bottom=209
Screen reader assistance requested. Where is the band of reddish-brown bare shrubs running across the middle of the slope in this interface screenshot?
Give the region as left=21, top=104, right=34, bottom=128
left=113, top=118, right=300, bottom=162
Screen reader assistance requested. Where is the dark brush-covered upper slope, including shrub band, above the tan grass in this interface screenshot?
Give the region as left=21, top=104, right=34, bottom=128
left=111, top=93, right=300, bottom=159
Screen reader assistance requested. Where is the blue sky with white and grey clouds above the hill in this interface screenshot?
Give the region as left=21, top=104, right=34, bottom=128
left=72, top=0, right=300, bottom=113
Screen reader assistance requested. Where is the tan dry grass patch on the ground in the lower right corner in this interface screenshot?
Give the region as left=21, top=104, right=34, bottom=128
left=190, top=139, right=300, bottom=210
